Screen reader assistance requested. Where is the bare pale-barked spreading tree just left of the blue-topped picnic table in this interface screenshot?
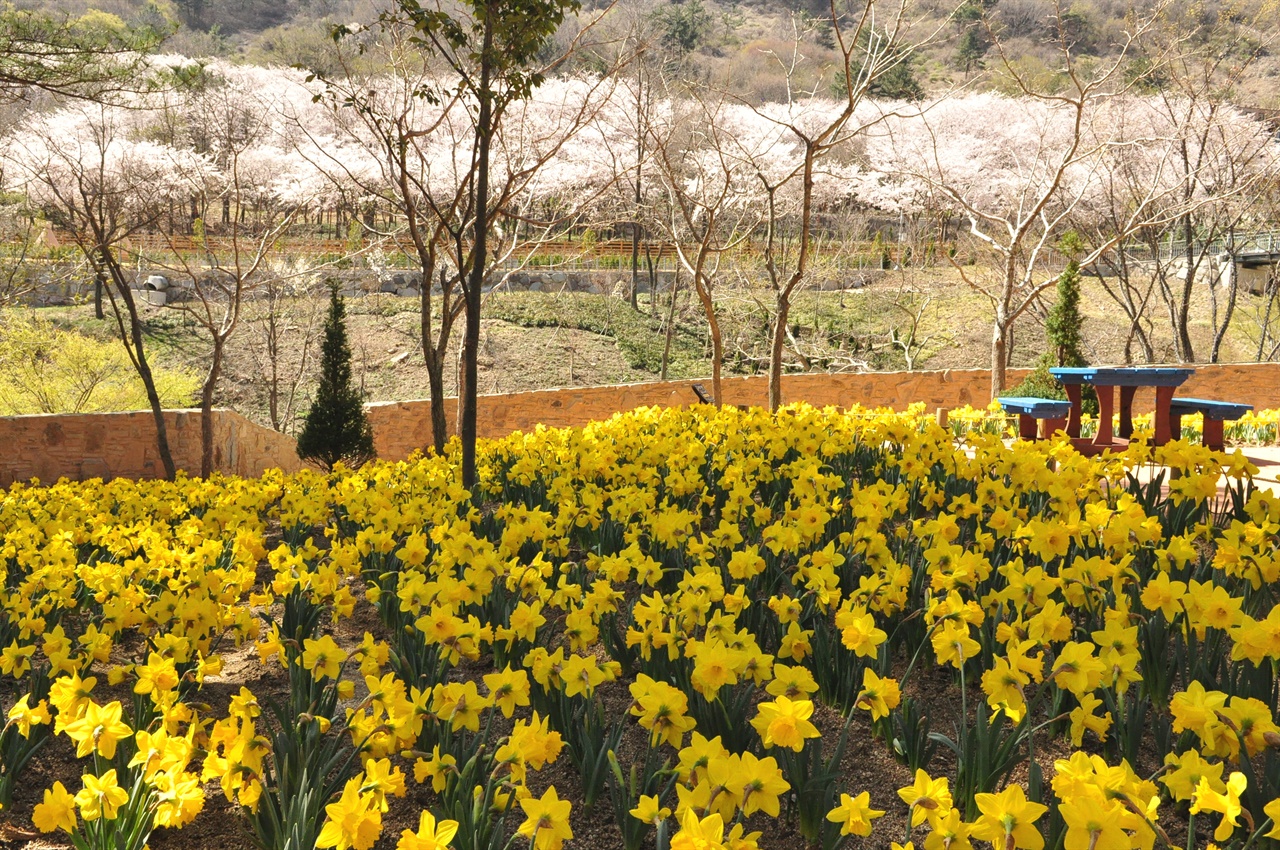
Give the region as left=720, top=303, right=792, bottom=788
left=870, top=0, right=1177, bottom=397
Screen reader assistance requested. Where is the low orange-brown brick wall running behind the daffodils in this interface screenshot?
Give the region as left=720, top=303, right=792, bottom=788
left=0, top=364, right=1280, bottom=486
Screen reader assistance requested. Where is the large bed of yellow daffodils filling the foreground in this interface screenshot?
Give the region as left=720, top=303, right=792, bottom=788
left=0, top=406, right=1280, bottom=850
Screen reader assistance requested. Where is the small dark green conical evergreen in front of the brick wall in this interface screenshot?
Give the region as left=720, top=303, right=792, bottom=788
left=298, top=285, right=374, bottom=470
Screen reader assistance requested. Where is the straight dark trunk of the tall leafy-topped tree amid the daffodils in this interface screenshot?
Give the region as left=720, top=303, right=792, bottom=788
left=458, top=11, right=494, bottom=488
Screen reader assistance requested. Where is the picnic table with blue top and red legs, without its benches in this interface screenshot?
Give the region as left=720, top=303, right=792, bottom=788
left=1048, top=366, right=1196, bottom=454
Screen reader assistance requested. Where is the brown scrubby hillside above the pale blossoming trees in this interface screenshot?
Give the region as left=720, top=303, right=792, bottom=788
left=18, top=0, right=1280, bottom=109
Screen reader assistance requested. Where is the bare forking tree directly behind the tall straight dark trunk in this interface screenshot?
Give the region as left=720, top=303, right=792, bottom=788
left=310, top=18, right=624, bottom=452
